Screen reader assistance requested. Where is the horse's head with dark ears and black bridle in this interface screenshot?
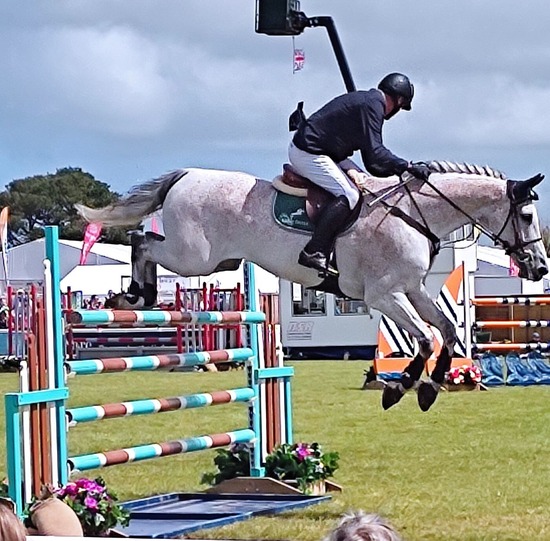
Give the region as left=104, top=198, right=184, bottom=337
left=502, top=174, right=548, bottom=282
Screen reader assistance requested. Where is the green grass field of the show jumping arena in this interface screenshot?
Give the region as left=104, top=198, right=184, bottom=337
left=0, top=361, right=550, bottom=541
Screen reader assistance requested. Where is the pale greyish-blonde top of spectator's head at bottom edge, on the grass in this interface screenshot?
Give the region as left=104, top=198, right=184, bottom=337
left=324, top=511, right=402, bottom=541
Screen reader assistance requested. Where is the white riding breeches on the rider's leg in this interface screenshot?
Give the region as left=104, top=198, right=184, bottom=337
left=288, top=141, right=359, bottom=209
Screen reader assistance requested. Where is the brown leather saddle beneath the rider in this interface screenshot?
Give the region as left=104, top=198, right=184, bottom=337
left=272, top=163, right=362, bottom=225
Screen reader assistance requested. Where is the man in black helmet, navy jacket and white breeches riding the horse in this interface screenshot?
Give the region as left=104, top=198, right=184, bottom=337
left=288, top=73, right=430, bottom=276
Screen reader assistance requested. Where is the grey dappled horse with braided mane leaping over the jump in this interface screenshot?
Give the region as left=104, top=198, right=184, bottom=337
left=77, top=162, right=548, bottom=411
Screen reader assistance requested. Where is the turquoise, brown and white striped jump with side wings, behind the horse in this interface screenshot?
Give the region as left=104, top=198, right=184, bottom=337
left=5, top=227, right=302, bottom=524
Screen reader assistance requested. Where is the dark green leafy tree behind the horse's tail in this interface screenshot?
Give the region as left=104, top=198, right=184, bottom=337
left=0, top=167, right=128, bottom=244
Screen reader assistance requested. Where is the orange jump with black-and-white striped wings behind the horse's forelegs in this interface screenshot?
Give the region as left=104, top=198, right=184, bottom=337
left=374, top=265, right=550, bottom=388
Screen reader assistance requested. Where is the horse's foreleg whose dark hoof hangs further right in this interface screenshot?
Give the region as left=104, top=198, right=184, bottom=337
left=409, top=286, right=457, bottom=411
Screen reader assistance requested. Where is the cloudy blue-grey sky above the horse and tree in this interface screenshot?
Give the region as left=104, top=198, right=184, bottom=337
left=0, top=0, right=550, bottom=219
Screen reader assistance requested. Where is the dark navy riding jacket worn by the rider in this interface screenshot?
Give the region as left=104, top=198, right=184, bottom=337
left=293, top=89, right=408, bottom=177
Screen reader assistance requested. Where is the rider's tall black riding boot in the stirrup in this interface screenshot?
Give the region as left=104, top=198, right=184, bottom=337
left=298, top=195, right=351, bottom=276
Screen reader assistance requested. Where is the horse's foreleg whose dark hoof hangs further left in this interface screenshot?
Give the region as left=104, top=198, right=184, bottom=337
left=374, top=292, right=433, bottom=409
